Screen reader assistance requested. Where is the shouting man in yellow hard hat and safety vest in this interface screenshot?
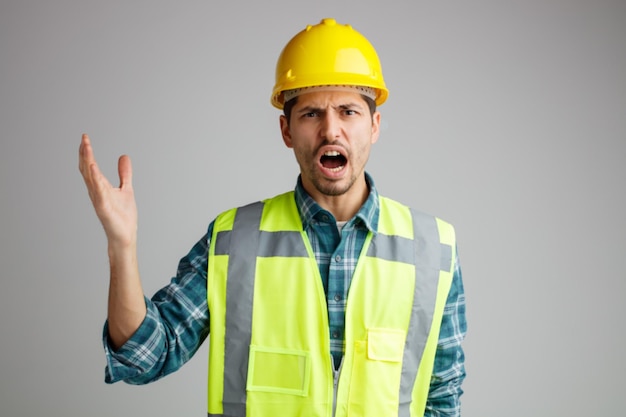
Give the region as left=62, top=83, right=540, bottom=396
left=80, top=19, right=466, bottom=416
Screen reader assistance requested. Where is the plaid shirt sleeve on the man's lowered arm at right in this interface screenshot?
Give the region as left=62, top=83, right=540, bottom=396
left=424, top=249, right=467, bottom=417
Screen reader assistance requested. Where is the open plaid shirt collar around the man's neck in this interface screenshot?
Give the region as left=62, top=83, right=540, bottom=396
left=295, top=172, right=380, bottom=233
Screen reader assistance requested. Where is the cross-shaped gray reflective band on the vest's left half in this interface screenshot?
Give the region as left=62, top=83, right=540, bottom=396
left=215, top=203, right=309, bottom=417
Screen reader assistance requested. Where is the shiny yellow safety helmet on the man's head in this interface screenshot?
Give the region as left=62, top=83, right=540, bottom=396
left=271, top=19, right=389, bottom=109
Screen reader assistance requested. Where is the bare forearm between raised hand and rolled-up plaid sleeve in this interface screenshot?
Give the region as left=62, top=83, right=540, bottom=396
left=108, top=242, right=146, bottom=349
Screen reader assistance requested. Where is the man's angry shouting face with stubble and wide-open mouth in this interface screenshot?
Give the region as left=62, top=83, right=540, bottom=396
left=280, top=91, right=380, bottom=199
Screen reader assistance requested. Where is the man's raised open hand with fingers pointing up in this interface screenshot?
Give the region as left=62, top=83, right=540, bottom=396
left=78, top=134, right=137, bottom=247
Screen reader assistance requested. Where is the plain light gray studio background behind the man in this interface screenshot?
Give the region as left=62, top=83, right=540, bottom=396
left=0, top=0, right=626, bottom=417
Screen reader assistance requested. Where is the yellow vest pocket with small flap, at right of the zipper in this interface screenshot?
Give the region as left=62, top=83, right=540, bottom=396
left=348, top=329, right=406, bottom=417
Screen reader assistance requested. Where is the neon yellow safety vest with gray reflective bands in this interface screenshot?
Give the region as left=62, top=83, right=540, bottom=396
left=207, top=192, right=456, bottom=417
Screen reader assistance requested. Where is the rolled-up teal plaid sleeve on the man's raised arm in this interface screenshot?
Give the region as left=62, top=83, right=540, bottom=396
left=103, top=223, right=213, bottom=385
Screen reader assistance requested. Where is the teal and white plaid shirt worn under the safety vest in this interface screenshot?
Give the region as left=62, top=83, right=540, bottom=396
left=103, top=174, right=466, bottom=417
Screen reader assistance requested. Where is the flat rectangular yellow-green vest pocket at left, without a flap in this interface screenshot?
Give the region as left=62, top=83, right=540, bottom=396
left=246, top=345, right=311, bottom=396
